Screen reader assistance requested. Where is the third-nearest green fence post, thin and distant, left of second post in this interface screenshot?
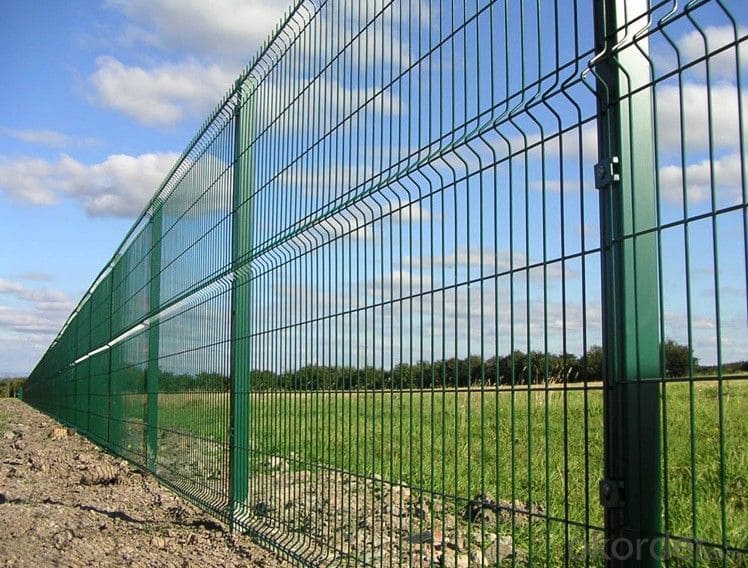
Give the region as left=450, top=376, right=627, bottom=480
left=146, top=203, right=162, bottom=472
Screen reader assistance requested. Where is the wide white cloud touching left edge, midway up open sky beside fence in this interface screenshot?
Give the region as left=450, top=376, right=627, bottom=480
left=0, top=153, right=178, bottom=217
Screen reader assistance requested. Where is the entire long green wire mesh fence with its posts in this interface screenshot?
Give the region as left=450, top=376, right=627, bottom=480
left=24, top=0, right=748, bottom=566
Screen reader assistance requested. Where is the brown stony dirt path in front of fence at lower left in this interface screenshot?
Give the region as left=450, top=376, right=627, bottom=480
left=0, top=399, right=289, bottom=568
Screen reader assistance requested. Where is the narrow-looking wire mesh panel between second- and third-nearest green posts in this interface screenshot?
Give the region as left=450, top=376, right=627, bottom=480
left=149, top=97, right=234, bottom=515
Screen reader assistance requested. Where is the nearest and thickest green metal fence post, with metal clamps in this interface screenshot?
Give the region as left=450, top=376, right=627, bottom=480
left=595, top=0, right=663, bottom=566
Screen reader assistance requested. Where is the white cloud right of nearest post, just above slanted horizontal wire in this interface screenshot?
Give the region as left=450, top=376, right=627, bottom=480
left=659, top=154, right=742, bottom=205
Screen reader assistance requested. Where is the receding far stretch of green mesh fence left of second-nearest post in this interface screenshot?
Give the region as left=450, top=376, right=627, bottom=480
left=26, top=74, right=234, bottom=515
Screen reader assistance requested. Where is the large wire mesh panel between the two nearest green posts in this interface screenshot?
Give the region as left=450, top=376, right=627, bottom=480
left=234, top=2, right=603, bottom=566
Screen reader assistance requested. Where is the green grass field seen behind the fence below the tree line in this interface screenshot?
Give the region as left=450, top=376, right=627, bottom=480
left=153, top=380, right=748, bottom=565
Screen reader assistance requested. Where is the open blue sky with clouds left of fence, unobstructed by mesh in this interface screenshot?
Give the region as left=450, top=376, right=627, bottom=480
left=0, top=0, right=286, bottom=375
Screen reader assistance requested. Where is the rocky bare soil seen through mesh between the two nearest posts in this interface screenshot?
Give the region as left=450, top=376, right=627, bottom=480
left=243, top=466, right=528, bottom=568
